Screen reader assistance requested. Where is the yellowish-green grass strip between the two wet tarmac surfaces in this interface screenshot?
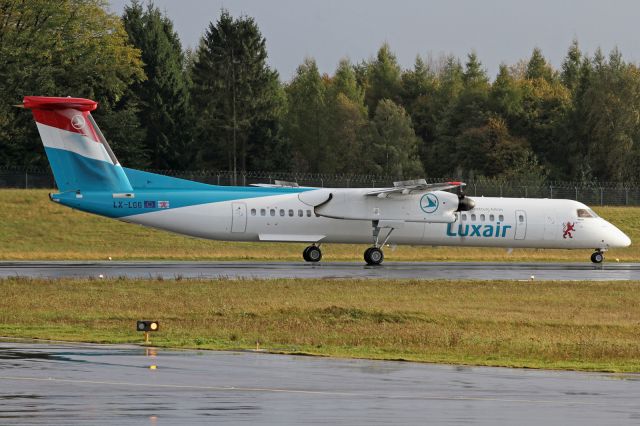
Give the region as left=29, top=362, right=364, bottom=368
left=0, top=279, right=640, bottom=372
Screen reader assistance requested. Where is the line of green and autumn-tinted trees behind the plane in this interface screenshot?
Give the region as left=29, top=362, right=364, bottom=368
left=0, top=0, right=640, bottom=182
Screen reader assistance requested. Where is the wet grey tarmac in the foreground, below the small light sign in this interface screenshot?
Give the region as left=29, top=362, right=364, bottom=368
left=0, top=341, right=640, bottom=425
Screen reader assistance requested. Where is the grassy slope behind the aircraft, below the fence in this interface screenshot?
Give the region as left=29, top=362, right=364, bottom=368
left=0, top=190, right=640, bottom=262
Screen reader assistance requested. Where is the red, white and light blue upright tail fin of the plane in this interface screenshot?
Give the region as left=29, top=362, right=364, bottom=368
left=21, top=96, right=133, bottom=192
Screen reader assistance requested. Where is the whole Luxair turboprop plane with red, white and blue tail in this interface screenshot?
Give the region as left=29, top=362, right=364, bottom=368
left=23, top=96, right=631, bottom=265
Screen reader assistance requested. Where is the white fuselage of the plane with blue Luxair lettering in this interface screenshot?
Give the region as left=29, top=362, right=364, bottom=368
left=121, top=193, right=630, bottom=250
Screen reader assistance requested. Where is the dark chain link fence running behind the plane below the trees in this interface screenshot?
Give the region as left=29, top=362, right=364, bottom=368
left=0, top=169, right=640, bottom=206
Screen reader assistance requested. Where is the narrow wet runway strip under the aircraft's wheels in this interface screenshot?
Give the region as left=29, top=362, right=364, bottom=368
left=0, top=261, right=640, bottom=281
